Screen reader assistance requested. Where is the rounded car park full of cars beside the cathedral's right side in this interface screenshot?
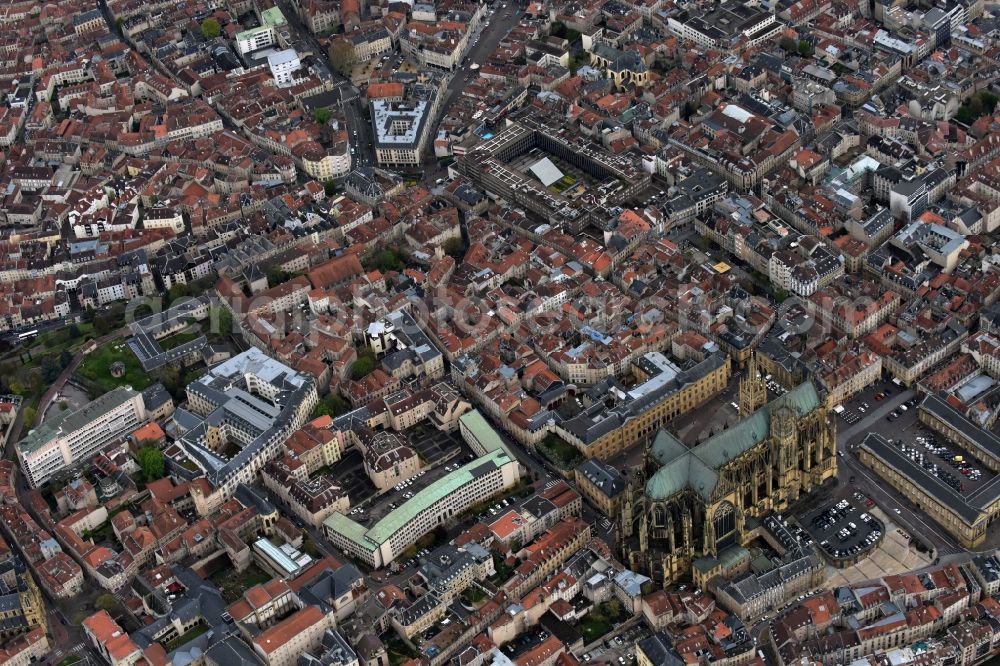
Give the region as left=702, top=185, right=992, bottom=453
left=801, top=492, right=885, bottom=560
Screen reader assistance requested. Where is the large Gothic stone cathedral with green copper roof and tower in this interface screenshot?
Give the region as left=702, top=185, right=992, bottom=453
left=617, top=374, right=837, bottom=585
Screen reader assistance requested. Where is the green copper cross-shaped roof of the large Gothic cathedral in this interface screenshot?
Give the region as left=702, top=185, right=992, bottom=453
left=646, top=381, right=821, bottom=500
